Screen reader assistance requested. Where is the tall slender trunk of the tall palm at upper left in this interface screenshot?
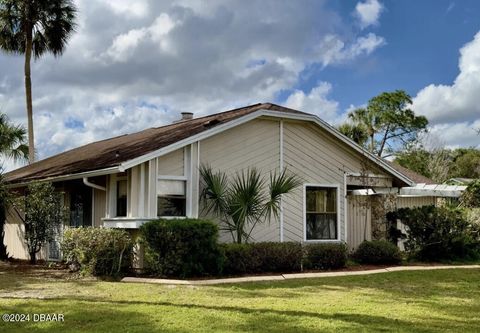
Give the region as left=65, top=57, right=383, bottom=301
left=24, top=16, right=35, bottom=163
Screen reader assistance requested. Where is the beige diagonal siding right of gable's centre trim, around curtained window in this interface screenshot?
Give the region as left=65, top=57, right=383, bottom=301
left=283, top=122, right=387, bottom=241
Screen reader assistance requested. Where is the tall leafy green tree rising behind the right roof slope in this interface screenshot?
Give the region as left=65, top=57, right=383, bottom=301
left=342, top=90, right=428, bottom=156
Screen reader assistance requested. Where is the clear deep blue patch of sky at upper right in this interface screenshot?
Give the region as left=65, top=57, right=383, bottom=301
left=278, top=0, right=480, bottom=109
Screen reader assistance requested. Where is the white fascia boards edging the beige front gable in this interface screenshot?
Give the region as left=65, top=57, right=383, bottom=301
left=119, top=109, right=415, bottom=186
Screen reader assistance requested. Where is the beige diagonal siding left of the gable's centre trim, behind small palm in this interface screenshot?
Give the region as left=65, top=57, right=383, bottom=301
left=199, top=119, right=280, bottom=242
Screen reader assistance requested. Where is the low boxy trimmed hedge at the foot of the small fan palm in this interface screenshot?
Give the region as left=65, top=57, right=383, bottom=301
left=223, top=242, right=302, bottom=275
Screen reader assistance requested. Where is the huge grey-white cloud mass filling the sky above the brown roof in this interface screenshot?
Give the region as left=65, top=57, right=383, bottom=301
left=0, top=0, right=384, bottom=170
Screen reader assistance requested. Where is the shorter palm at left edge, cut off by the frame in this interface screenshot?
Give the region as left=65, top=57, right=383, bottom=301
left=0, top=114, right=28, bottom=259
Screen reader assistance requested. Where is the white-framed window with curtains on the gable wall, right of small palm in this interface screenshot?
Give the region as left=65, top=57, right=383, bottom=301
left=305, top=186, right=338, bottom=240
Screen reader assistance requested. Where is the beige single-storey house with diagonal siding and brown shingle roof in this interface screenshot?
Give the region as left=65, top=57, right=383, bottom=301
left=1, top=103, right=464, bottom=259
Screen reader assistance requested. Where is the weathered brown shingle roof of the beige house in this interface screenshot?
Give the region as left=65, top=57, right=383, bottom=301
left=5, top=103, right=306, bottom=183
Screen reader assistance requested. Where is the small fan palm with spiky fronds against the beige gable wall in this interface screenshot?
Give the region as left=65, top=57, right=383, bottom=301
left=200, top=165, right=300, bottom=243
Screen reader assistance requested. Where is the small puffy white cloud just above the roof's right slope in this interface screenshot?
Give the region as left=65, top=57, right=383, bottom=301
left=285, top=82, right=339, bottom=123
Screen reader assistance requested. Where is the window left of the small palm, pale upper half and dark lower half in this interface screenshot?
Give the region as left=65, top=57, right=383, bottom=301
left=157, top=180, right=187, bottom=217
